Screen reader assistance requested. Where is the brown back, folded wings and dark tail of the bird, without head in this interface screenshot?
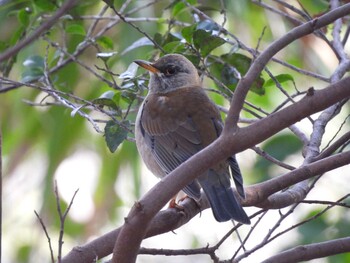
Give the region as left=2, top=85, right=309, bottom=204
left=138, top=87, right=249, bottom=223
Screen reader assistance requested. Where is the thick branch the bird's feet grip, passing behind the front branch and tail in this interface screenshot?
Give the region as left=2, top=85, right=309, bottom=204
left=62, top=152, right=350, bottom=263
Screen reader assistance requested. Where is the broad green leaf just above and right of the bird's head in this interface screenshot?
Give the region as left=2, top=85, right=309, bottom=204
left=193, top=29, right=226, bottom=57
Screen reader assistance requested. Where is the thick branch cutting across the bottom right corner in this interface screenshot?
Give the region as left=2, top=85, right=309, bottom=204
left=263, top=237, right=350, bottom=263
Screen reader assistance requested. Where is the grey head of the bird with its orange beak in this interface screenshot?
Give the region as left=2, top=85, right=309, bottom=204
left=134, top=54, right=201, bottom=93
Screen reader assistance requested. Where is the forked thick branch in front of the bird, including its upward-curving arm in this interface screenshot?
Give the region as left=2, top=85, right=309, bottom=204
left=112, top=4, right=350, bottom=263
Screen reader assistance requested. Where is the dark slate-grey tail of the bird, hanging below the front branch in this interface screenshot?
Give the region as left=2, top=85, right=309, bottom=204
left=199, top=170, right=250, bottom=224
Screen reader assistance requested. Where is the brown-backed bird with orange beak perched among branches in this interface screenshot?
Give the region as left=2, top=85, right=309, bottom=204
left=134, top=54, right=250, bottom=224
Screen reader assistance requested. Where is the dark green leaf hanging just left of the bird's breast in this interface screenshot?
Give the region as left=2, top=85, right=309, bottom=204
left=105, top=120, right=130, bottom=153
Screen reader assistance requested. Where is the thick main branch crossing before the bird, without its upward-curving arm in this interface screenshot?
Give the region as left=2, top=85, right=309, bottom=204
left=114, top=72, right=350, bottom=262
